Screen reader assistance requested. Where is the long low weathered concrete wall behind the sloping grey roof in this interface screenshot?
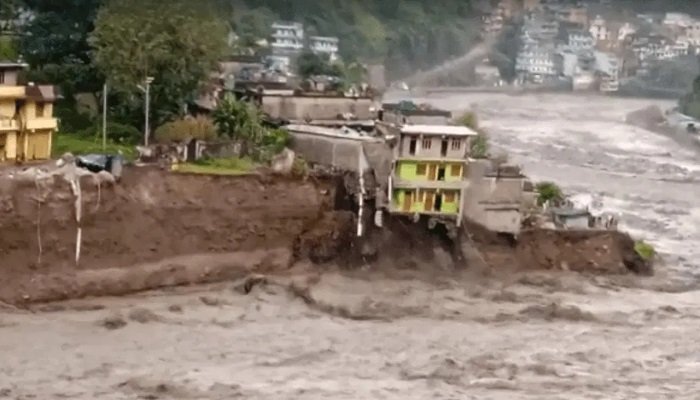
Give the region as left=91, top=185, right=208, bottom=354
left=262, top=96, right=372, bottom=120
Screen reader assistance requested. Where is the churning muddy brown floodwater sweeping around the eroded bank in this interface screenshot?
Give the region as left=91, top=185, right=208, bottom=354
left=0, top=94, right=700, bottom=400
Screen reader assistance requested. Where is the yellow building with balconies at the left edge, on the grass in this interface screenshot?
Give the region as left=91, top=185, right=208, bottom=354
left=0, top=62, right=58, bottom=162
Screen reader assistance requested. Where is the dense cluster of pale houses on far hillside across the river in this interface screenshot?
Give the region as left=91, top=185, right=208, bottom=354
left=484, top=0, right=700, bottom=92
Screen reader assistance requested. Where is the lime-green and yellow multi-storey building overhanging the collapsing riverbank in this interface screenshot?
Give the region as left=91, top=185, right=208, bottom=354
left=388, top=125, right=477, bottom=226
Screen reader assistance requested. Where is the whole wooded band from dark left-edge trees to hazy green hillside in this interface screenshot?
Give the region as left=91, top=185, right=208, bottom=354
left=0, top=0, right=490, bottom=141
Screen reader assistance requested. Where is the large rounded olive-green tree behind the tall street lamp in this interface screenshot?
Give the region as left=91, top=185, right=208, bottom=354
left=90, top=0, right=229, bottom=124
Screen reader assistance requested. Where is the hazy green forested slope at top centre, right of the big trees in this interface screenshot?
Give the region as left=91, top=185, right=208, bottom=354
left=233, top=0, right=484, bottom=77
